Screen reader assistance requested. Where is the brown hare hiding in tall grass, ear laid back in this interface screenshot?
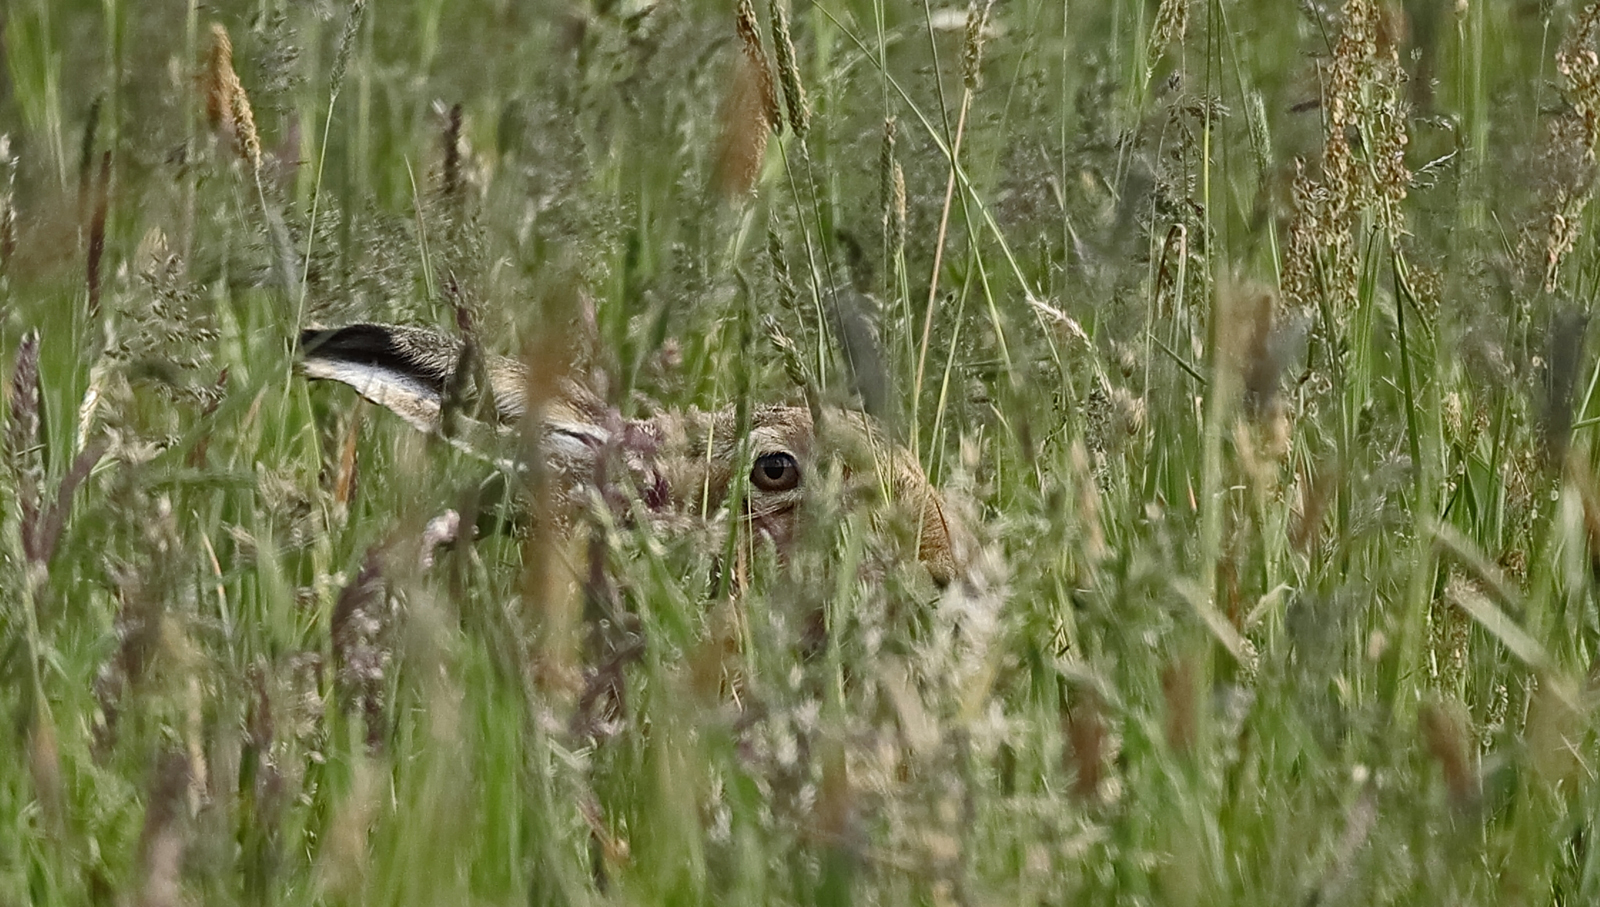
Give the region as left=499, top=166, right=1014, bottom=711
left=299, top=323, right=965, bottom=585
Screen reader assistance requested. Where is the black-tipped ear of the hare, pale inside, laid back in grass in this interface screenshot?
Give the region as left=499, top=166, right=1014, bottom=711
left=299, top=325, right=461, bottom=432
